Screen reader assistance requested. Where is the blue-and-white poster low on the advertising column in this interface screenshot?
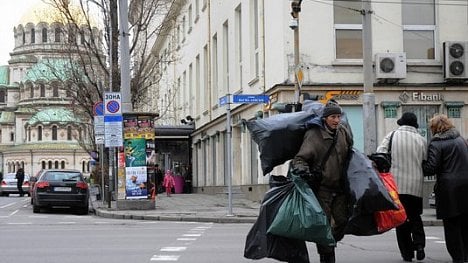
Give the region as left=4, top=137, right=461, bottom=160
left=125, top=166, right=148, bottom=199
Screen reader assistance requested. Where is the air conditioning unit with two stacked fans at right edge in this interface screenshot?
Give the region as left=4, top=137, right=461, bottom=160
left=444, top=41, right=468, bottom=80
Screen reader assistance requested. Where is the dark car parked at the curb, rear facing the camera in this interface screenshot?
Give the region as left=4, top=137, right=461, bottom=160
left=31, top=169, right=89, bottom=214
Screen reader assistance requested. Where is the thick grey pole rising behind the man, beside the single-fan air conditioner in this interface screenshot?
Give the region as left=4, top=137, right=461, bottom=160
left=361, top=0, right=377, bottom=155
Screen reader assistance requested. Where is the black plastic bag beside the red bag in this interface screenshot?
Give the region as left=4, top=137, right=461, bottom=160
left=345, top=149, right=398, bottom=236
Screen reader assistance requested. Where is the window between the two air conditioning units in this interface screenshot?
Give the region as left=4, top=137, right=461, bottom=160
left=401, top=0, right=436, bottom=59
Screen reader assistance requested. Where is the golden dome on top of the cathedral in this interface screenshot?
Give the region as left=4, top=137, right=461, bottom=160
left=18, top=0, right=96, bottom=27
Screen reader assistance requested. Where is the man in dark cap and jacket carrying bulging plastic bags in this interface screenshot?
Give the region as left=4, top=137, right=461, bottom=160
left=292, top=101, right=353, bottom=263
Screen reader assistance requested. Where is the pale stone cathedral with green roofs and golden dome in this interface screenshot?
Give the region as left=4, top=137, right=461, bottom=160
left=0, top=2, right=97, bottom=175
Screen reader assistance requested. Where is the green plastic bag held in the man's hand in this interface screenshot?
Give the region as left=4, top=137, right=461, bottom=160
left=268, top=176, right=336, bottom=246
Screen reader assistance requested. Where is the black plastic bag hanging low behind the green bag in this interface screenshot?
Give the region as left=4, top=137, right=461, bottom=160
left=244, top=181, right=309, bottom=263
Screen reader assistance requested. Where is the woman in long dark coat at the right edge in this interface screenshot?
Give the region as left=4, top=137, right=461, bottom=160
left=423, top=115, right=468, bottom=263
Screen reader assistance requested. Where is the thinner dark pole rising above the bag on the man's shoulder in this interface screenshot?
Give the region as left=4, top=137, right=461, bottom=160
left=289, top=0, right=302, bottom=111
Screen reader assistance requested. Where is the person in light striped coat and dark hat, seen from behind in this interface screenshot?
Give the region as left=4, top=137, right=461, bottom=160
left=377, top=112, right=427, bottom=262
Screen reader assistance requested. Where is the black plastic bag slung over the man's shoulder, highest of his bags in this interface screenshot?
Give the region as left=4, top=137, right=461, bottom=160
left=247, top=111, right=315, bottom=175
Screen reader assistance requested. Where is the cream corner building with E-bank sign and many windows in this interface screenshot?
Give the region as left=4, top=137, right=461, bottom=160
left=144, top=0, right=468, bottom=200
